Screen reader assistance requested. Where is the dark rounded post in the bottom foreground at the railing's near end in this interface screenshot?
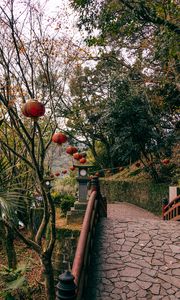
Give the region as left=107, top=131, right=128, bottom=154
left=56, top=271, right=77, bottom=300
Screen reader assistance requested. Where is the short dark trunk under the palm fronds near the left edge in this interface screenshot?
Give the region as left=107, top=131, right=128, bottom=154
left=5, top=227, right=17, bottom=269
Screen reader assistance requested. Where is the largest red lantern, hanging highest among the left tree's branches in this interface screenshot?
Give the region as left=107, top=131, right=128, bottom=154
left=22, top=100, right=45, bottom=118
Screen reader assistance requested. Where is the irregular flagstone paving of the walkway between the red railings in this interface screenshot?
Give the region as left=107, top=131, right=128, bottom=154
left=85, top=203, right=180, bottom=300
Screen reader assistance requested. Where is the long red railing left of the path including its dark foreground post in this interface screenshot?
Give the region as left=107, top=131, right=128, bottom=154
left=56, top=177, right=107, bottom=300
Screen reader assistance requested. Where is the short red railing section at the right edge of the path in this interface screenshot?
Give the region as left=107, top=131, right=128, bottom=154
left=162, top=195, right=180, bottom=221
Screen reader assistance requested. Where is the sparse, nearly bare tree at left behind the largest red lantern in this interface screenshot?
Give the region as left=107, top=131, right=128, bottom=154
left=0, top=0, right=83, bottom=300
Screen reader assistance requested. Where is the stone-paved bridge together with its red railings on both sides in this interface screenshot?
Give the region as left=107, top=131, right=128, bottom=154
left=57, top=178, right=180, bottom=300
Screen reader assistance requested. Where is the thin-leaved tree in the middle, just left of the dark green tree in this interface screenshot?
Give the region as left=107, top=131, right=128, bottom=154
left=65, top=54, right=121, bottom=167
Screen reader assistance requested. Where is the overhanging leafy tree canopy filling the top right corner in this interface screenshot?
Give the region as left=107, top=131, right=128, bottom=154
left=71, top=0, right=180, bottom=110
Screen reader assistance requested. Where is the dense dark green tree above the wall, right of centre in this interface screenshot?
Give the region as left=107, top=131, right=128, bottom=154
left=106, top=81, right=174, bottom=181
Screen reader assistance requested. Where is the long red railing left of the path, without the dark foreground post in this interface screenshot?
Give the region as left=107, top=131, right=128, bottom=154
left=72, top=180, right=107, bottom=300
